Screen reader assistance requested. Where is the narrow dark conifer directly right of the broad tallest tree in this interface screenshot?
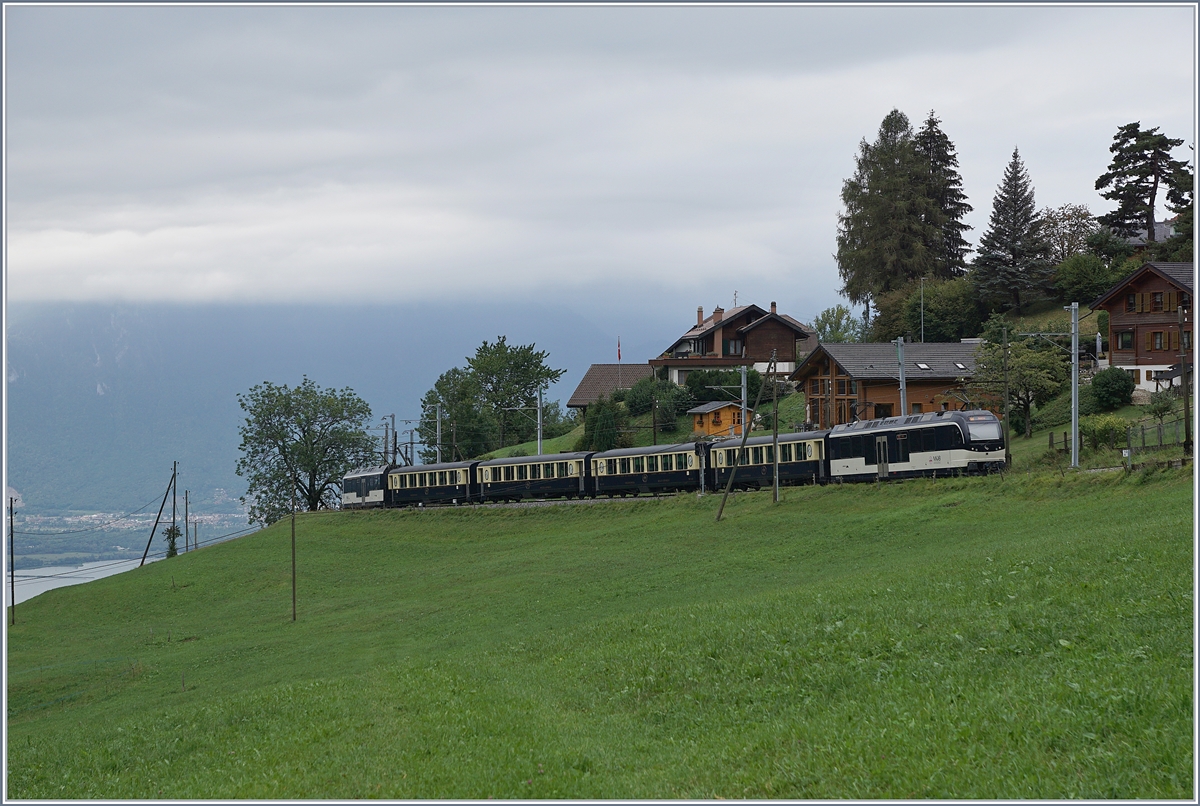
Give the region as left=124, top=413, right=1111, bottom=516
left=914, top=109, right=974, bottom=279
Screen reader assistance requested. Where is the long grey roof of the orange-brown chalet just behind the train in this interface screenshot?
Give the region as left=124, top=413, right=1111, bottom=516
left=791, top=342, right=979, bottom=383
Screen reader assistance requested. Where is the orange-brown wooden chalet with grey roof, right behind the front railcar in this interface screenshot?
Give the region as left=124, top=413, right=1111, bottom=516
left=791, top=339, right=979, bottom=428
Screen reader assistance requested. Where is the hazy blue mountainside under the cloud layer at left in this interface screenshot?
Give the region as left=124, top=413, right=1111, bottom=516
left=6, top=302, right=678, bottom=515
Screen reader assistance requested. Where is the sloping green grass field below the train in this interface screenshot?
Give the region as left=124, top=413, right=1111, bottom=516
left=7, top=469, right=1194, bottom=799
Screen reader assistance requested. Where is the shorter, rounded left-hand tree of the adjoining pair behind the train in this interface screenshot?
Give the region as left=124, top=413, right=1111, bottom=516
left=416, top=367, right=499, bottom=463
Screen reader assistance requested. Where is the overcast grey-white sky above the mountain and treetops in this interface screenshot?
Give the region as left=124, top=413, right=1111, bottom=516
left=5, top=5, right=1196, bottom=323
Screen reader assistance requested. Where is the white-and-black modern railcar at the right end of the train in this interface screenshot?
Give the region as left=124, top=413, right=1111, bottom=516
left=826, top=410, right=1004, bottom=481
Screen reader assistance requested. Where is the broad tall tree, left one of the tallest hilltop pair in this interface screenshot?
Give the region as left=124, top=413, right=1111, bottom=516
left=835, top=109, right=942, bottom=306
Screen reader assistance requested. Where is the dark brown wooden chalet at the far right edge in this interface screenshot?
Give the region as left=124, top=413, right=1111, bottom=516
left=1088, top=263, right=1195, bottom=391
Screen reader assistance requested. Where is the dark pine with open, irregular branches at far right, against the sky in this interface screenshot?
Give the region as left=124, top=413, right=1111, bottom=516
left=1096, top=121, right=1192, bottom=243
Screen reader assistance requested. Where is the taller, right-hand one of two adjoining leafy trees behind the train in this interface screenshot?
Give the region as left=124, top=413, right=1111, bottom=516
left=467, top=336, right=566, bottom=447
